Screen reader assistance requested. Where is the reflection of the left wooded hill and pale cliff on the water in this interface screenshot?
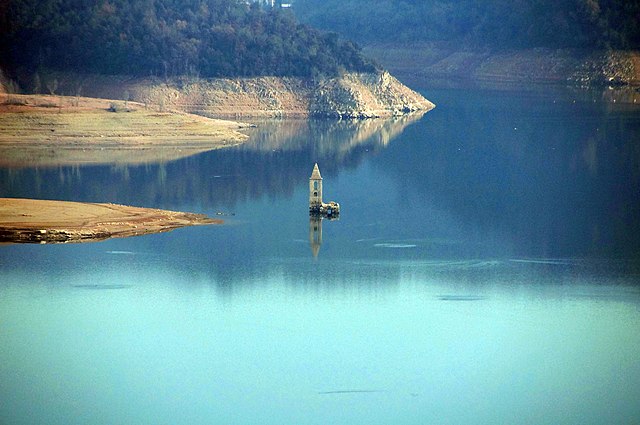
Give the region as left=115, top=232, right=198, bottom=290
left=0, top=115, right=420, bottom=207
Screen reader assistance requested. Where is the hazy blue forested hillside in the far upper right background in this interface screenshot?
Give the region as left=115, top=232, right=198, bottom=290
left=295, top=0, right=640, bottom=49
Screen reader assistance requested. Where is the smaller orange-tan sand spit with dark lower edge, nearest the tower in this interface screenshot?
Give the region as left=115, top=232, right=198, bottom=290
left=0, top=198, right=222, bottom=243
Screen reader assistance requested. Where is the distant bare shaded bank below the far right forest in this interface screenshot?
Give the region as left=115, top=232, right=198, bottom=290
left=364, top=42, right=640, bottom=102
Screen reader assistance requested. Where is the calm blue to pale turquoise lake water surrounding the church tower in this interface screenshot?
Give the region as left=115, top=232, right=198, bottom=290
left=0, top=90, right=640, bottom=424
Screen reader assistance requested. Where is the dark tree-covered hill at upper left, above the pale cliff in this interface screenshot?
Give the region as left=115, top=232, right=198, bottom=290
left=0, top=0, right=374, bottom=77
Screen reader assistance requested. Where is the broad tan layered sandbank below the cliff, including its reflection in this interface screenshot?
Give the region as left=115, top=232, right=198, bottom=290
left=0, top=95, right=248, bottom=167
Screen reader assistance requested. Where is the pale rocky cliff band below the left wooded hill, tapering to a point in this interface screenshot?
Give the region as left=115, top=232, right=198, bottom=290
left=75, top=72, right=435, bottom=118
